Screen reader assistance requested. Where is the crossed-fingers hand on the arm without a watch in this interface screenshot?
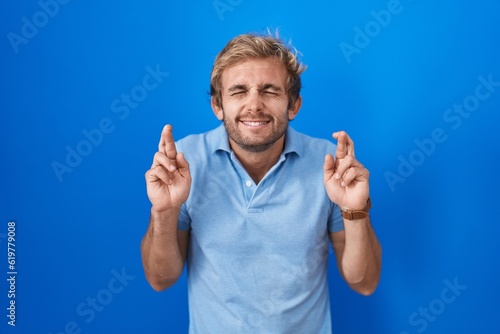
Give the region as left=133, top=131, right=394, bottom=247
left=145, top=125, right=191, bottom=212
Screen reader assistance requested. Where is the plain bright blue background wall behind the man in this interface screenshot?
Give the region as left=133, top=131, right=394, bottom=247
left=0, top=0, right=500, bottom=334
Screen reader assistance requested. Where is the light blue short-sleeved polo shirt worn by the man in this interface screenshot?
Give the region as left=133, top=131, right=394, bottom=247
left=176, top=125, right=344, bottom=334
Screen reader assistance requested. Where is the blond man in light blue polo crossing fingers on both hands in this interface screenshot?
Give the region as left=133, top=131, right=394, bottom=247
left=141, top=35, right=381, bottom=334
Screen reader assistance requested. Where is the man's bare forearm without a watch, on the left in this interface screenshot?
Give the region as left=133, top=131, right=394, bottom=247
left=141, top=209, right=185, bottom=291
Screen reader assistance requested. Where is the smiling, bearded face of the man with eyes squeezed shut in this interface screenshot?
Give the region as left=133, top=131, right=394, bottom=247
left=212, top=58, right=301, bottom=152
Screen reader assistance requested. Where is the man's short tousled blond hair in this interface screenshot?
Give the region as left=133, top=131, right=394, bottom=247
left=210, top=31, right=307, bottom=109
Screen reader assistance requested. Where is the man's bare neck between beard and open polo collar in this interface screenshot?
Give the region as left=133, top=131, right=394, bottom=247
left=229, top=136, right=285, bottom=184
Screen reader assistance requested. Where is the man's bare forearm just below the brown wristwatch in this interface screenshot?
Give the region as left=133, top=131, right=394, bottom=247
left=341, top=217, right=382, bottom=295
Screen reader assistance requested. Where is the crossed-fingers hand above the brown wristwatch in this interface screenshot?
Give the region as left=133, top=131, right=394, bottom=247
left=323, top=131, right=370, bottom=210
